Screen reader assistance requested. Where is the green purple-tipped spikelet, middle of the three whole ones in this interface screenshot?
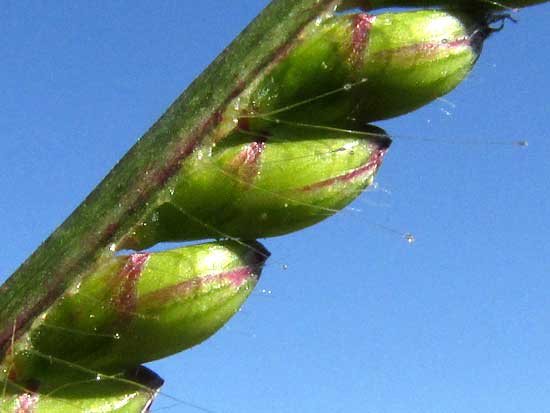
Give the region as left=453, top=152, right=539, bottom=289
left=123, top=124, right=390, bottom=249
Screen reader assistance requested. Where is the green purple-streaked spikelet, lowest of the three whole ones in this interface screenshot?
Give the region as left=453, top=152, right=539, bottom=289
left=8, top=241, right=269, bottom=379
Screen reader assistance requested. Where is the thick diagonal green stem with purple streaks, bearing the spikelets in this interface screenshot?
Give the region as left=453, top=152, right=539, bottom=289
left=0, top=0, right=338, bottom=351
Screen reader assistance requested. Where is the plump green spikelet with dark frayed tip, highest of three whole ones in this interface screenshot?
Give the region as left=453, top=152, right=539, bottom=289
left=246, top=10, right=491, bottom=125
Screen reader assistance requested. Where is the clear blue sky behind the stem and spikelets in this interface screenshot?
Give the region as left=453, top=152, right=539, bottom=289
left=0, top=0, right=550, bottom=413
